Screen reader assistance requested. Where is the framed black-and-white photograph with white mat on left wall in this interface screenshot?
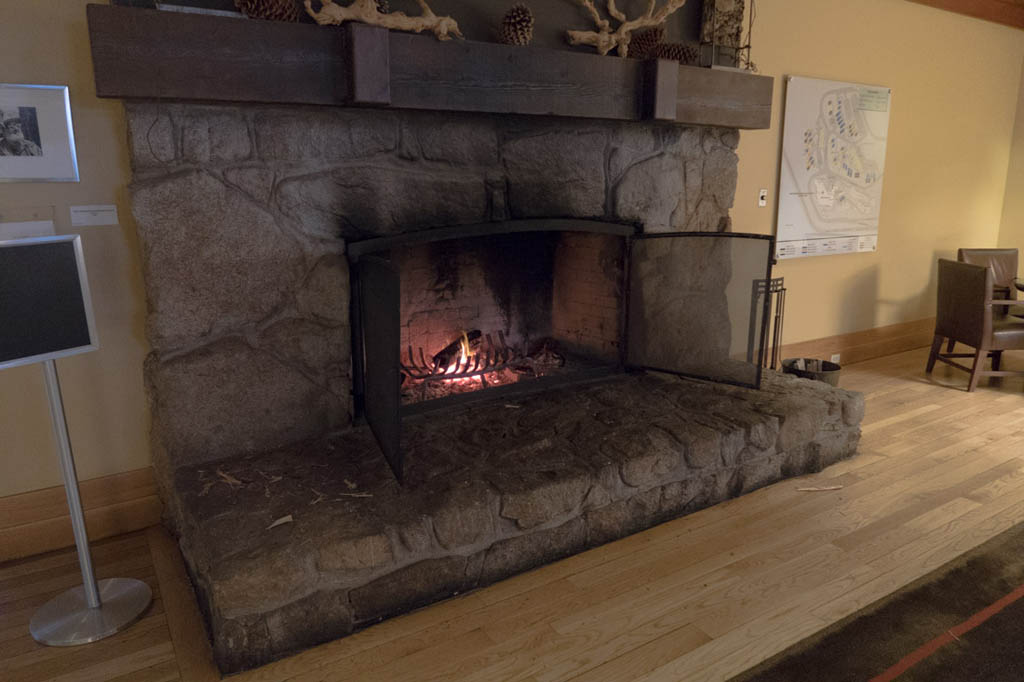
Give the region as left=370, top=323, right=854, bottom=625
left=0, top=83, right=78, bottom=182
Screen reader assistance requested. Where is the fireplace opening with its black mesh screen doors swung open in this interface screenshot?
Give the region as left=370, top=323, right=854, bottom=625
left=348, top=220, right=774, bottom=481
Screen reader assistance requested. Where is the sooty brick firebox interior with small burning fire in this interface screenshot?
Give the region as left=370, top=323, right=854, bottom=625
left=389, top=231, right=624, bottom=404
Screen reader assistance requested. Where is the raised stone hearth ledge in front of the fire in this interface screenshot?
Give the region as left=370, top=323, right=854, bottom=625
left=171, top=372, right=864, bottom=673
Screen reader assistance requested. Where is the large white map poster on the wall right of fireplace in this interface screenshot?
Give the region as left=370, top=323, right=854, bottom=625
left=775, top=76, right=892, bottom=259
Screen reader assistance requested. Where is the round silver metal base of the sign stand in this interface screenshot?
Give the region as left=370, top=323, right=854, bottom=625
left=29, top=578, right=153, bottom=646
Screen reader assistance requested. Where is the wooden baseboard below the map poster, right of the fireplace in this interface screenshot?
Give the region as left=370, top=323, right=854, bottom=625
left=782, top=317, right=935, bottom=365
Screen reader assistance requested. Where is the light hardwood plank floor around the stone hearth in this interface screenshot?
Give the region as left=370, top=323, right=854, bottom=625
left=0, top=349, right=1024, bottom=682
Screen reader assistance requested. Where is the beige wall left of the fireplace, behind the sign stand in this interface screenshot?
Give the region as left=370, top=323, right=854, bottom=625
left=0, top=0, right=150, bottom=497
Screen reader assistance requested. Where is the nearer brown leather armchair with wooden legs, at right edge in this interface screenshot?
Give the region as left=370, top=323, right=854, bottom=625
left=926, top=258, right=1024, bottom=391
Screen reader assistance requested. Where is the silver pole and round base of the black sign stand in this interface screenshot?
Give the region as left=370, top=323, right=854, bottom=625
left=29, top=359, right=153, bottom=646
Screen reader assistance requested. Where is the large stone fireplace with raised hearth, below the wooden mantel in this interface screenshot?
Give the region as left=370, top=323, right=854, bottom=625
left=126, top=101, right=863, bottom=672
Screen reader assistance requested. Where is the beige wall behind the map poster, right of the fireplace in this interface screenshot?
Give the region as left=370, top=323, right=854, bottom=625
left=732, top=0, right=1024, bottom=343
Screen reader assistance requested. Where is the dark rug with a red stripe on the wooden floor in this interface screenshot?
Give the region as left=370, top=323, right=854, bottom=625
left=732, top=524, right=1024, bottom=682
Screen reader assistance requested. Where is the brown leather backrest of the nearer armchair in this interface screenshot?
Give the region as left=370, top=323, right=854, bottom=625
left=935, top=258, right=992, bottom=348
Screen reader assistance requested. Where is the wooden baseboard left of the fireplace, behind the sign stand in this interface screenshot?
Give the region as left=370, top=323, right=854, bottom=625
left=0, top=467, right=163, bottom=561
